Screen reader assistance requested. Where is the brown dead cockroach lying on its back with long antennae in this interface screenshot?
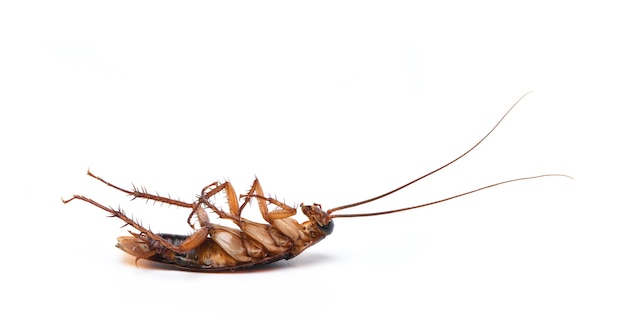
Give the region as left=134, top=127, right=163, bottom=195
left=62, top=93, right=571, bottom=272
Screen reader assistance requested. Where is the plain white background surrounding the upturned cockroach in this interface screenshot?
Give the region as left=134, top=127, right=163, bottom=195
left=0, top=1, right=626, bottom=332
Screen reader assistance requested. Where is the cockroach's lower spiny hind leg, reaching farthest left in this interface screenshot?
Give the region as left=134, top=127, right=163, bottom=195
left=62, top=195, right=211, bottom=253
